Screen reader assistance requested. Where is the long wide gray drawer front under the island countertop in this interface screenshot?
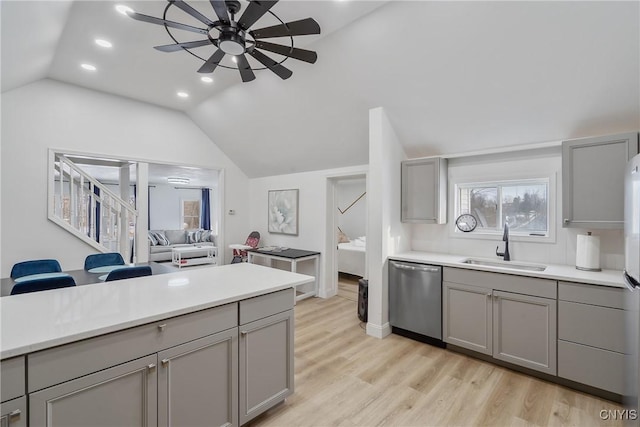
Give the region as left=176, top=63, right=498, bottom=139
left=27, top=303, right=238, bottom=392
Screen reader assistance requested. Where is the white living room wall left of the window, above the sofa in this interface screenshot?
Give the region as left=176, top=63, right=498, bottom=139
left=149, top=184, right=202, bottom=230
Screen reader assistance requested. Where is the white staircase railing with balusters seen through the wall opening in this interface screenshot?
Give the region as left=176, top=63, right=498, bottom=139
left=47, top=153, right=138, bottom=262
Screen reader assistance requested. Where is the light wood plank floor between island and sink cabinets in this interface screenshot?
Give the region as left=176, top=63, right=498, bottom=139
left=250, top=282, right=622, bottom=427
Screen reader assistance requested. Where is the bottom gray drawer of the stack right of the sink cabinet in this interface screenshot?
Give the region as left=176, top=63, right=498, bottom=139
left=558, top=340, right=625, bottom=394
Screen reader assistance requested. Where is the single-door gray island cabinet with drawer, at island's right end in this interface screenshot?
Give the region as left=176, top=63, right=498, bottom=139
left=239, top=290, right=294, bottom=424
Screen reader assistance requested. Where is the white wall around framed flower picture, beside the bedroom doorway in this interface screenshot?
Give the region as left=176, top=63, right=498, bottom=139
left=248, top=166, right=367, bottom=297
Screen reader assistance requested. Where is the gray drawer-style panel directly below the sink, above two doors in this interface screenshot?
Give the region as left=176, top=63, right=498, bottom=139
left=442, top=267, right=557, bottom=299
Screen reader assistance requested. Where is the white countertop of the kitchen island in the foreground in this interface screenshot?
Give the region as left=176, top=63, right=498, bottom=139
left=0, top=263, right=315, bottom=359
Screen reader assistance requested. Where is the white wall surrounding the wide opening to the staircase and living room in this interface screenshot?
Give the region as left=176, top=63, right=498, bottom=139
left=0, top=79, right=249, bottom=277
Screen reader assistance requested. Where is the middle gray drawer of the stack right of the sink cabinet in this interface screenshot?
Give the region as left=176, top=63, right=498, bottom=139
left=558, top=301, right=625, bottom=353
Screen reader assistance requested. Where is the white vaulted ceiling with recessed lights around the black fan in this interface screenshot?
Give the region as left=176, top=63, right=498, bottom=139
left=1, top=0, right=640, bottom=177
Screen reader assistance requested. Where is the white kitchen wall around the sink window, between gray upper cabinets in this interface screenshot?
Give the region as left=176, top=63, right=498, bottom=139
left=411, top=146, right=624, bottom=269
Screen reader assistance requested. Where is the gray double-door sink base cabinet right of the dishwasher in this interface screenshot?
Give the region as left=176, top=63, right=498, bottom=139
left=443, top=268, right=557, bottom=375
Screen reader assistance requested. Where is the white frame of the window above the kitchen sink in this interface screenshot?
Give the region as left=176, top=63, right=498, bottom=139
left=449, top=174, right=556, bottom=243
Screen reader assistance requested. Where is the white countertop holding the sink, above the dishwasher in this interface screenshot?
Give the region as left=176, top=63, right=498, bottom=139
left=389, top=251, right=625, bottom=288
